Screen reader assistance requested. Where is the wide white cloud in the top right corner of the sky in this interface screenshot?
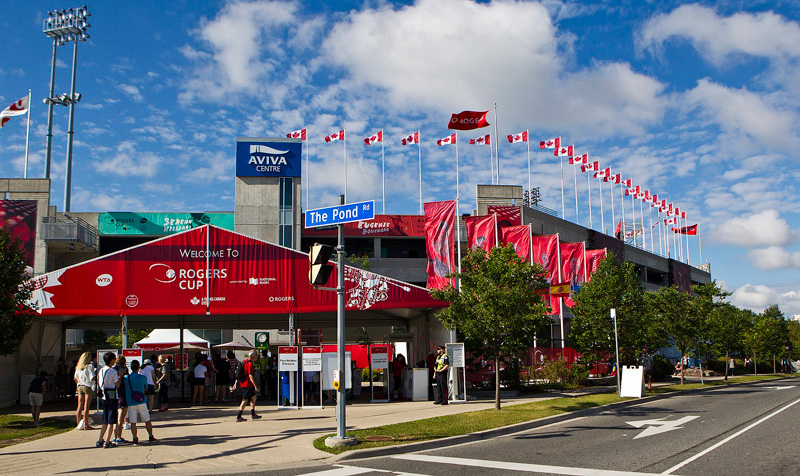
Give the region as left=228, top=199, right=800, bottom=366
left=638, top=4, right=800, bottom=65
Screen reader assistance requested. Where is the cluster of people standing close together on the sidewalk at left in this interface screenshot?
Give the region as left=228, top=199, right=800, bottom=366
left=73, top=352, right=172, bottom=448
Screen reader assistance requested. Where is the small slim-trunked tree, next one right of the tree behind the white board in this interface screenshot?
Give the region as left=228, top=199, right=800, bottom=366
left=652, top=286, right=706, bottom=384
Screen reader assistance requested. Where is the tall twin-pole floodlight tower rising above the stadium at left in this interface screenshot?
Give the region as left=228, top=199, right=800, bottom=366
left=42, top=5, right=92, bottom=212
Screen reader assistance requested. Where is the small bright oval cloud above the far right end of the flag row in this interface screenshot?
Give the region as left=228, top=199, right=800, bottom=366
left=712, top=210, right=795, bottom=247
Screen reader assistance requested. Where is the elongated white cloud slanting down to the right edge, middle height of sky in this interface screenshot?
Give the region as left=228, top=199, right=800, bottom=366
left=685, top=79, right=798, bottom=150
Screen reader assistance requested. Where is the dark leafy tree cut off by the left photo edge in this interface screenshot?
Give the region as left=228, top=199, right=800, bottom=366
left=0, top=227, right=36, bottom=356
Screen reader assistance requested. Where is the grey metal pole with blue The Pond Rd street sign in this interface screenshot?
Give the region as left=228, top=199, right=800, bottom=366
left=305, top=195, right=375, bottom=447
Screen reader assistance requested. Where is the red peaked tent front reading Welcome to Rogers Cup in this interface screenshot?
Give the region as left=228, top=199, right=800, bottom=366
left=31, top=225, right=446, bottom=316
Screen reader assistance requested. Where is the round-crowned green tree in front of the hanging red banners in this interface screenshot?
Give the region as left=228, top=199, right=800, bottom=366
left=431, top=246, right=552, bottom=410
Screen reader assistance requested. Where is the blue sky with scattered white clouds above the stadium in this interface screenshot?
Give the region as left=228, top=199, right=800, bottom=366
left=0, top=0, right=800, bottom=315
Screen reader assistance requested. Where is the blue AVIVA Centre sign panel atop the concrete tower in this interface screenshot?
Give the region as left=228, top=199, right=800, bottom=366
left=236, top=137, right=303, bottom=177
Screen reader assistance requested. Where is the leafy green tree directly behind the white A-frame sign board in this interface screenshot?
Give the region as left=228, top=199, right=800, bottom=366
left=571, top=254, right=666, bottom=364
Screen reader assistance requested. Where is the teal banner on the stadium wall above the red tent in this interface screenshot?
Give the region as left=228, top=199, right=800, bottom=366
left=97, top=212, right=234, bottom=236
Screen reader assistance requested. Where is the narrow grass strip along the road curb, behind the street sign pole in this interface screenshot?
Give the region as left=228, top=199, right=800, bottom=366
left=314, top=374, right=788, bottom=454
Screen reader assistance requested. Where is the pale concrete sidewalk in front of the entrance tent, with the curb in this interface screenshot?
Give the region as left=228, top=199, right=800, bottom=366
left=0, top=379, right=756, bottom=475
